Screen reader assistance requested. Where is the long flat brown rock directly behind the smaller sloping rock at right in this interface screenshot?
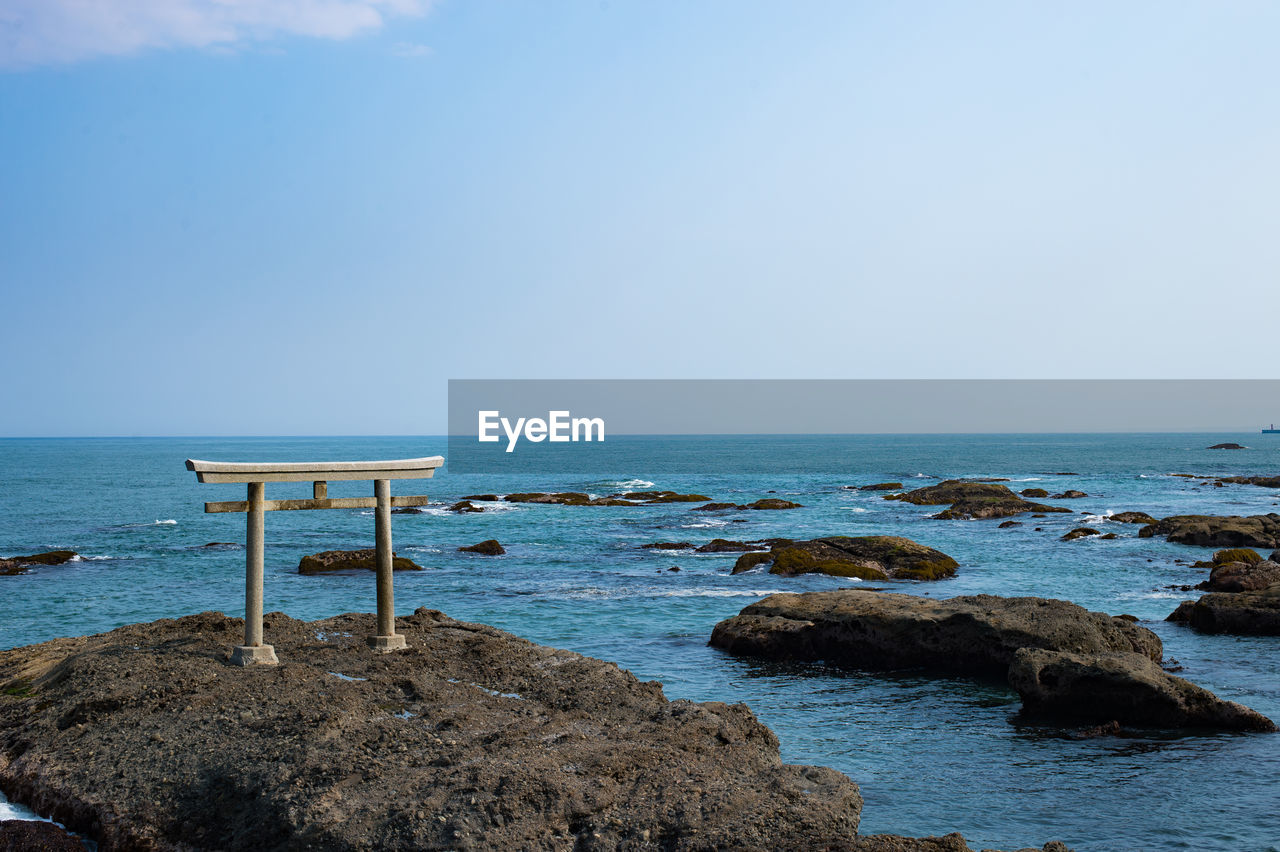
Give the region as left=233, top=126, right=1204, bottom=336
left=710, top=588, right=1162, bottom=678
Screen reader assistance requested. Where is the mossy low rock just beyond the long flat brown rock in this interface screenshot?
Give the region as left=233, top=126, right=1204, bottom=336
left=732, top=536, right=959, bottom=580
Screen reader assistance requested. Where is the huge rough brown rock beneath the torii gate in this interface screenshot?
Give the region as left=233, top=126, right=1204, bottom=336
left=0, top=609, right=861, bottom=852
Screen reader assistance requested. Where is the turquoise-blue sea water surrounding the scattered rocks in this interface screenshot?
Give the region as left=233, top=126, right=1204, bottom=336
left=0, top=434, right=1280, bottom=852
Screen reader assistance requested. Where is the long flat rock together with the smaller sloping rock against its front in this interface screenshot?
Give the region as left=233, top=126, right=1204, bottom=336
left=710, top=590, right=1280, bottom=732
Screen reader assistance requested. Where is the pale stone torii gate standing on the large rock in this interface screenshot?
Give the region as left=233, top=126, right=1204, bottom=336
left=187, top=455, right=444, bottom=665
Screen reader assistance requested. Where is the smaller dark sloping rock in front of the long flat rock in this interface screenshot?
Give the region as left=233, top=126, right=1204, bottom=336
left=1009, top=647, right=1276, bottom=732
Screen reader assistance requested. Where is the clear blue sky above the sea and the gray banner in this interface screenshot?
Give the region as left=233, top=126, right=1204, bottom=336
left=0, top=0, right=1280, bottom=435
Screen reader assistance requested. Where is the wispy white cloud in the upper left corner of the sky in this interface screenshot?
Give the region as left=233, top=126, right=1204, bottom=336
left=0, top=0, right=430, bottom=68
